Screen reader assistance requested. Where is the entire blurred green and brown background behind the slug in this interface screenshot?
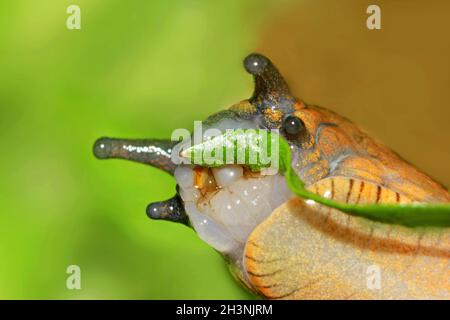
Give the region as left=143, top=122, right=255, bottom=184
left=0, top=0, right=450, bottom=299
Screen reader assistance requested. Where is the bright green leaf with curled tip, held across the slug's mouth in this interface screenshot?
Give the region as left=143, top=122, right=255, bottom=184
left=183, top=130, right=450, bottom=227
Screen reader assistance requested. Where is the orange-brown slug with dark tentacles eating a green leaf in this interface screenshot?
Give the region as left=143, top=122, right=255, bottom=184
left=94, top=53, right=450, bottom=299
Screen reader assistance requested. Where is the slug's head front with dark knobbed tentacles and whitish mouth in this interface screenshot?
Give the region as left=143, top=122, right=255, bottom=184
left=94, top=53, right=304, bottom=258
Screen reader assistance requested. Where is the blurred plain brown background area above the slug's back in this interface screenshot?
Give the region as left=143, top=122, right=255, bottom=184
left=258, top=0, right=450, bottom=186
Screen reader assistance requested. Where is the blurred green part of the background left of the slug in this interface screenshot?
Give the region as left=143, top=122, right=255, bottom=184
left=0, top=0, right=284, bottom=299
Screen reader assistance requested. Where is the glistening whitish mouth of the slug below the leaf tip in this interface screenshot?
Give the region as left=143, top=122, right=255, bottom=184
left=174, top=165, right=291, bottom=256
